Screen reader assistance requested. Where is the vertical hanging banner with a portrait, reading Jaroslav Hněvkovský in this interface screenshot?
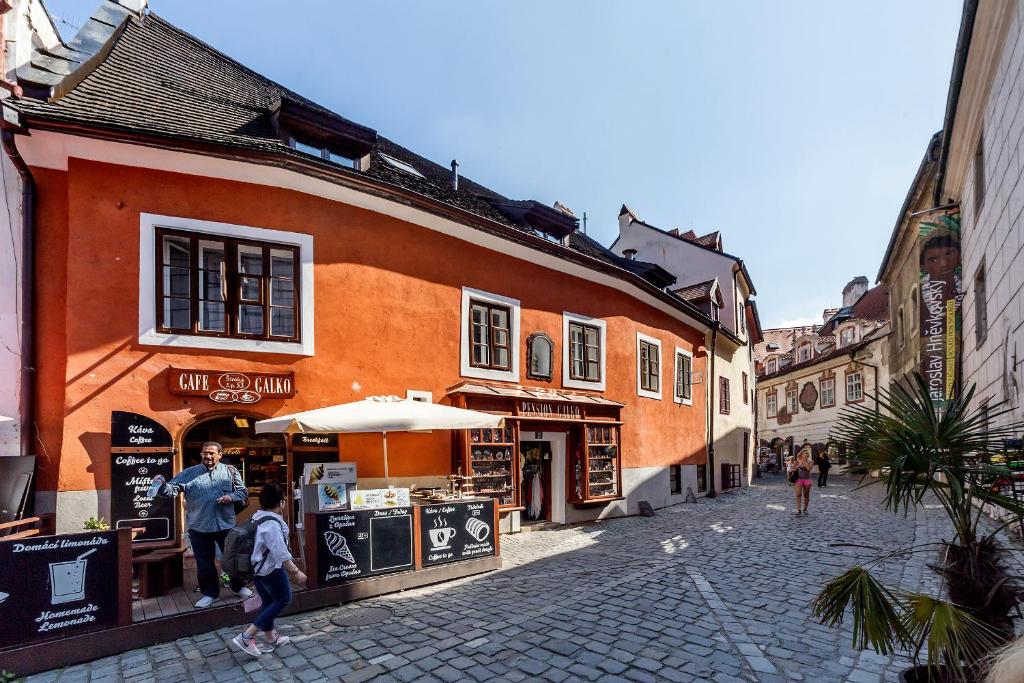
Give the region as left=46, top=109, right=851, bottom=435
left=919, top=213, right=963, bottom=405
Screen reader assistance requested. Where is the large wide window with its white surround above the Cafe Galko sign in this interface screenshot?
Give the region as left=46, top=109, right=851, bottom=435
left=138, top=213, right=313, bottom=355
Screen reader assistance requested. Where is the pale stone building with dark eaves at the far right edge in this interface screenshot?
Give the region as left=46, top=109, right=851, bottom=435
left=935, top=0, right=1024, bottom=423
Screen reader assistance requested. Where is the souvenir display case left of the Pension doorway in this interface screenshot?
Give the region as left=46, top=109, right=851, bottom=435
left=463, top=425, right=518, bottom=508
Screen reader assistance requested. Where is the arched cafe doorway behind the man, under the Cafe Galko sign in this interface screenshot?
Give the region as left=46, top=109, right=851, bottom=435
left=181, top=414, right=291, bottom=523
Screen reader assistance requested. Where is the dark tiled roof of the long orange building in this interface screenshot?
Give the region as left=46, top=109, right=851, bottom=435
left=5, top=7, right=707, bottom=318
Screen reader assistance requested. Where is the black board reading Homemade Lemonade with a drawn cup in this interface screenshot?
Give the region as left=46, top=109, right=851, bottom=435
left=0, top=531, right=119, bottom=647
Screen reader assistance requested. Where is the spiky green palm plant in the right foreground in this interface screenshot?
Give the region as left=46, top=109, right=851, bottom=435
left=812, top=375, right=1024, bottom=683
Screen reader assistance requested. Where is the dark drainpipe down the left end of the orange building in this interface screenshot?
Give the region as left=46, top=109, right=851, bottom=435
left=0, top=130, right=36, bottom=456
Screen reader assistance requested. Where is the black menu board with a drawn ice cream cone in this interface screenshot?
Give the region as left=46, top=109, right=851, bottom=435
left=316, top=507, right=414, bottom=586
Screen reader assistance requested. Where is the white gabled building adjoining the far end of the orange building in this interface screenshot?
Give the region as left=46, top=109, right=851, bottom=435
left=611, top=205, right=761, bottom=490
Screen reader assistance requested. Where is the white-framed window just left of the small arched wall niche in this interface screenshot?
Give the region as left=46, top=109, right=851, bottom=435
left=460, top=287, right=520, bottom=382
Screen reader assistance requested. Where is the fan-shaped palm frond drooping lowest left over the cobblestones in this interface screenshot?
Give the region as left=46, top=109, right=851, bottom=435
left=811, top=565, right=910, bottom=654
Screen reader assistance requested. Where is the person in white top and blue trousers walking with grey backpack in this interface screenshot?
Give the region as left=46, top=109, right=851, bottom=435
left=231, top=483, right=306, bottom=656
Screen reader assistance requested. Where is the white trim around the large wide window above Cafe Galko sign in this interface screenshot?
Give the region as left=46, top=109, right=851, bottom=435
left=138, top=213, right=313, bottom=355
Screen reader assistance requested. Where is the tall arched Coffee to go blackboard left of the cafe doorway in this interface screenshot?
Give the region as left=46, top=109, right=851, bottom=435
left=111, top=411, right=177, bottom=543
